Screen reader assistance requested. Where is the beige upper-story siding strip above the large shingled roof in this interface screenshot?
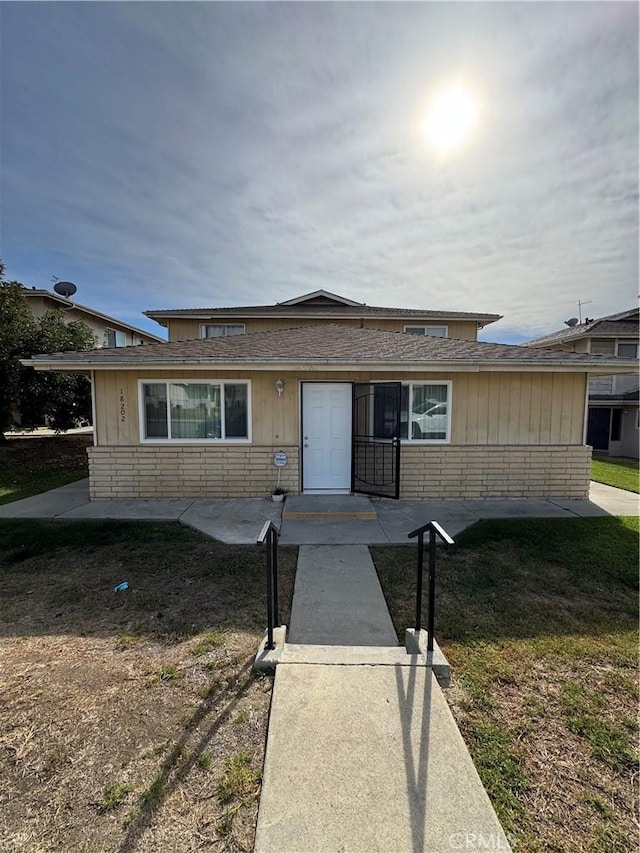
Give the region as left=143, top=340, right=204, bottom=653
left=166, top=317, right=478, bottom=341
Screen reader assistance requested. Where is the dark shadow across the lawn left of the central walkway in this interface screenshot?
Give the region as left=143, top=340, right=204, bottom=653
left=0, top=520, right=297, bottom=642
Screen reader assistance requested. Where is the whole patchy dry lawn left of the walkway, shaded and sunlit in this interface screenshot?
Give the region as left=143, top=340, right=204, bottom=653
left=0, top=521, right=296, bottom=853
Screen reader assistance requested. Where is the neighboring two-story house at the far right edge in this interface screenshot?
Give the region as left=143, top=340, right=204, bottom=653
left=526, top=308, right=640, bottom=459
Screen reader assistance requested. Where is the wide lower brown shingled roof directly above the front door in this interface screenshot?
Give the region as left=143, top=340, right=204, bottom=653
left=25, top=324, right=628, bottom=372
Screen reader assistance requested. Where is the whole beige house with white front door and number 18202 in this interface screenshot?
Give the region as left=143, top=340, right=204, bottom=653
left=26, top=292, right=633, bottom=499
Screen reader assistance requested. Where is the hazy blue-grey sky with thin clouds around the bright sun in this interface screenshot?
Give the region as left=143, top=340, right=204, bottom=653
left=0, top=0, right=639, bottom=343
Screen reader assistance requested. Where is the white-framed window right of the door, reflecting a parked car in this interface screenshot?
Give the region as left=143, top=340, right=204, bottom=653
left=374, top=382, right=451, bottom=444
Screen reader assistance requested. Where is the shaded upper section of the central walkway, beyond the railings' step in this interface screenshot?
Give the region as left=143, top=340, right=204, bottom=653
left=288, top=544, right=398, bottom=646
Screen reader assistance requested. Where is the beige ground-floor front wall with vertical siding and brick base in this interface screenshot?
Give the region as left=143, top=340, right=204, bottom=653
left=89, top=370, right=590, bottom=499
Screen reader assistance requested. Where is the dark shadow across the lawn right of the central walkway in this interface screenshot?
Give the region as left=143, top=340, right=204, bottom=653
left=371, top=517, right=638, bottom=643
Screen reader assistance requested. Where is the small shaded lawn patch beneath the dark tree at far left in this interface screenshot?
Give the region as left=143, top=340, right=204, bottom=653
left=0, top=434, right=93, bottom=504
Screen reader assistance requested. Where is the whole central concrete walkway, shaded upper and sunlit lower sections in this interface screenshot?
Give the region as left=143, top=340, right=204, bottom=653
left=254, top=545, right=510, bottom=853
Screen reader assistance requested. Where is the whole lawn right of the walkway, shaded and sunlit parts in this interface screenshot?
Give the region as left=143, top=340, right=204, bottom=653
left=371, top=518, right=638, bottom=853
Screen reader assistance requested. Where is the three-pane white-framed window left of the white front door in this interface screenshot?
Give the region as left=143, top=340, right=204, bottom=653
left=140, top=382, right=250, bottom=442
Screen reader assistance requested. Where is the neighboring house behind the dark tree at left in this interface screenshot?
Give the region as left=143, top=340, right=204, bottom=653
left=24, top=287, right=164, bottom=347
